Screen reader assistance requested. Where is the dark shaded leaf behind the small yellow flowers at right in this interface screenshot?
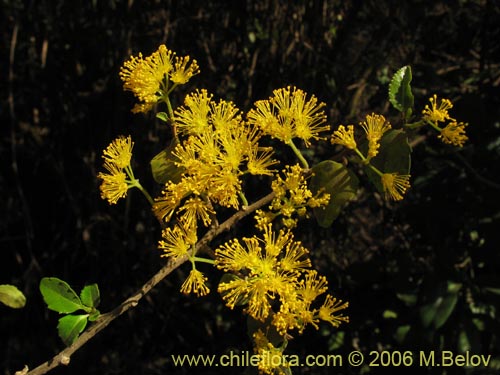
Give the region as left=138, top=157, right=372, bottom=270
left=365, top=129, right=411, bottom=193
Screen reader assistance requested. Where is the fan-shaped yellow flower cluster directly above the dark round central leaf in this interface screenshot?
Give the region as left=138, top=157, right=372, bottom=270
left=247, top=86, right=330, bottom=146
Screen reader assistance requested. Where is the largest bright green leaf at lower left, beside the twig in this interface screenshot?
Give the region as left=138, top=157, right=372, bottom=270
left=40, top=277, right=87, bottom=314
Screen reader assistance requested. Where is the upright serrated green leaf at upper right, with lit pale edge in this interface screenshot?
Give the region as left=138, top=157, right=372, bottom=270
left=389, top=65, right=414, bottom=119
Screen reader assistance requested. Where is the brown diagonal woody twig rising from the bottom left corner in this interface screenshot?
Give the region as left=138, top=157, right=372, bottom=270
left=16, top=193, right=274, bottom=375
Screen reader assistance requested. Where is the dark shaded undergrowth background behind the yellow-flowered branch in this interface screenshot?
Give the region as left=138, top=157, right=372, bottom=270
left=0, top=0, right=500, bottom=374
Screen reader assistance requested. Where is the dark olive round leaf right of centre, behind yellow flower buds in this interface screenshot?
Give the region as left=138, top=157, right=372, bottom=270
left=310, top=160, right=359, bottom=228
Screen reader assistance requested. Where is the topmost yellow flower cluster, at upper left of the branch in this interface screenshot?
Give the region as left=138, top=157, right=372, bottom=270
left=120, top=44, right=200, bottom=113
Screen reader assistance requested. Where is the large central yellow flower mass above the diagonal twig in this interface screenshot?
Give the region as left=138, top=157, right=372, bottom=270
left=153, top=90, right=275, bottom=226
